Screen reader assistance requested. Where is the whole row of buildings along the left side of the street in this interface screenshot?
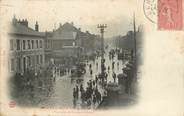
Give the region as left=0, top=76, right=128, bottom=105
left=8, top=17, right=100, bottom=74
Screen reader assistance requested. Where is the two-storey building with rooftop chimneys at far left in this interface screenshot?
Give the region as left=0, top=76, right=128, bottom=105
left=8, top=17, right=45, bottom=73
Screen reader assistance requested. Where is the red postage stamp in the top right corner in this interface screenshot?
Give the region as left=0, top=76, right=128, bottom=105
left=158, top=0, right=183, bottom=30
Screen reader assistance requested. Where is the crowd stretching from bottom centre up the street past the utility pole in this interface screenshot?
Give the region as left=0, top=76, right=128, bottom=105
left=73, top=47, right=123, bottom=108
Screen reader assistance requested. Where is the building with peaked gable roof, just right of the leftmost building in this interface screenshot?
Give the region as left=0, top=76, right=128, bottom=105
left=45, top=23, right=82, bottom=64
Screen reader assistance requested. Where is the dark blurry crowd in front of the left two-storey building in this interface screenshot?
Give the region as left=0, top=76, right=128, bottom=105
left=11, top=67, right=55, bottom=105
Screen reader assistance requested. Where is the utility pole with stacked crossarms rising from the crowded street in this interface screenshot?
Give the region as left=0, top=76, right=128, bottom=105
left=97, top=24, right=107, bottom=76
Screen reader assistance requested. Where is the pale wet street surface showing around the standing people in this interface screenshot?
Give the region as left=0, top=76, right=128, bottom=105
left=39, top=52, right=123, bottom=108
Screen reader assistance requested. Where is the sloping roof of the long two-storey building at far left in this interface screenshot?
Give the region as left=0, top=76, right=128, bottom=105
left=9, top=22, right=45, bottom=37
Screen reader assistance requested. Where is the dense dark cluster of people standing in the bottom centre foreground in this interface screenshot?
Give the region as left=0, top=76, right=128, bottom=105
left=73, top=57, right=117, bottom=108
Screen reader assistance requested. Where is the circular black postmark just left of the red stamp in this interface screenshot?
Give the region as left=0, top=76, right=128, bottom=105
left=143, top=0, right=157, bottom=23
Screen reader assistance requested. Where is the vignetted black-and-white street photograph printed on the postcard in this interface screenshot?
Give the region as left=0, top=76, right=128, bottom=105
left=8, top=3, right=143, bottom=109
